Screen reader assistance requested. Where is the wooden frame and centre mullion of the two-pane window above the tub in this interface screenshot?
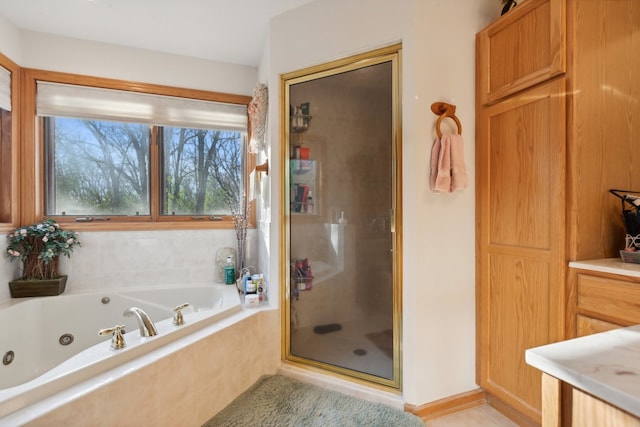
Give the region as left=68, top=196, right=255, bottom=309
left=20, top=68, right=255, bottom=231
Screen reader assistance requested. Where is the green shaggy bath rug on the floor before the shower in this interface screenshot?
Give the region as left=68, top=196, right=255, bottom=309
left=203, top=375, right=424, bottom=427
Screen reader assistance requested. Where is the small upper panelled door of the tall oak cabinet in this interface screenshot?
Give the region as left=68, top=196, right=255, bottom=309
left=476, top=0, right=566, bottom=105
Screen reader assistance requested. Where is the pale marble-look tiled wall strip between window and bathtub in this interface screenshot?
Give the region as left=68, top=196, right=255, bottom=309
left=0, top=227, right=258, bottom=301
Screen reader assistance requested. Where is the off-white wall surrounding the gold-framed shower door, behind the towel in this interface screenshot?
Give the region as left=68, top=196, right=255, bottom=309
left=268, top=0, right=500, bottom=405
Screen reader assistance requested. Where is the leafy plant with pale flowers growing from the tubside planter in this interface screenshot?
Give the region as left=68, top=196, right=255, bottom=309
left=7, top=219, right=81, bottom=279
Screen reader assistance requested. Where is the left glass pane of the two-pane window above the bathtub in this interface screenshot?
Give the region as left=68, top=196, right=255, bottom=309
left=43, top=117, right=151, bottom=216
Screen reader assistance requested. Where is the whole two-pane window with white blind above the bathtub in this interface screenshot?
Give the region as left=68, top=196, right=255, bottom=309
left=27, top=70, right=252, bottom=228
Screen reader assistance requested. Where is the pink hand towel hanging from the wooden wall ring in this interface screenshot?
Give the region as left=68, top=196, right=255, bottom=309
left=429, top=135, right=468, bottom=193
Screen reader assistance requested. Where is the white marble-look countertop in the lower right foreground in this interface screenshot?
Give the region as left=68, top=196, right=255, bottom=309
left=525, top=325, right=640, bottom=417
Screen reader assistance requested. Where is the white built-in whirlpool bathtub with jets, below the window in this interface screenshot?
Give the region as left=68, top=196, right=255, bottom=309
left=0, top=284, right=242, bottom=417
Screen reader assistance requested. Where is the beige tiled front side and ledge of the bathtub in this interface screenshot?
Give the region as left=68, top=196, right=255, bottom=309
left=0, top=309, right=280, bottom=426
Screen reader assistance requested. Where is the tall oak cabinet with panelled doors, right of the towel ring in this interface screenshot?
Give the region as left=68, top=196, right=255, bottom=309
left=475, top=0, right=640, bottom=423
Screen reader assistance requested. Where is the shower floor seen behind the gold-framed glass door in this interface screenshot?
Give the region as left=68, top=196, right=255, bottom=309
left=291, top=317, right=393, bottom=379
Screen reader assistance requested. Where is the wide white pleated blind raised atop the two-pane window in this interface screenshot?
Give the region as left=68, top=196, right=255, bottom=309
left=36, top=81, right=247, bottom=132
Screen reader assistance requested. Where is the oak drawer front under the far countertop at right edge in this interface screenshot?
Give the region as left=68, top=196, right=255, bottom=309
left=578, top=274, right=640, bottom=326
